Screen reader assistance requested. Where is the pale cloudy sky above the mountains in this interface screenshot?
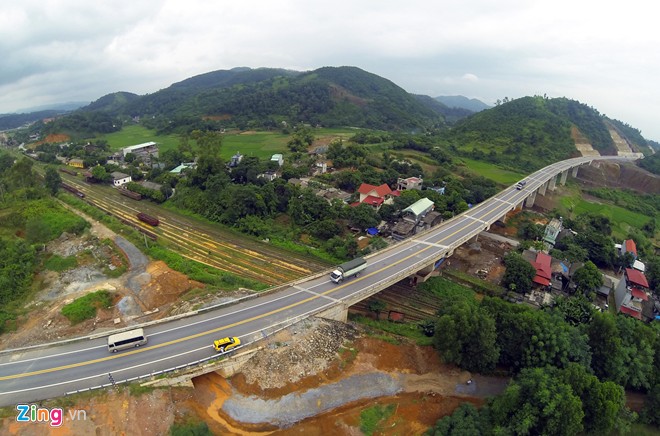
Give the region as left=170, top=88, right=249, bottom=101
left=0, top=0, right=660, bottom=140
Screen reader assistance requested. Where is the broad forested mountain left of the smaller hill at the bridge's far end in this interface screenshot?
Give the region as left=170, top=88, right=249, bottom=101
left=63, top=67, right=448, bottom=131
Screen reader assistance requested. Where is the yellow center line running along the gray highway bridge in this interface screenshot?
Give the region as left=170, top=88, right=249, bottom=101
left=0, top=202, right=493, bottom=381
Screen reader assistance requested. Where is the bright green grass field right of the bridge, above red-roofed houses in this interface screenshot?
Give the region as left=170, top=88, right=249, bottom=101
left=561, top=196, right=650, bottom=239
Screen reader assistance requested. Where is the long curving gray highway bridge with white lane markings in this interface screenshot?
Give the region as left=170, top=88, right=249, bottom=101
left=0, top=157, right=640, bottom=406
